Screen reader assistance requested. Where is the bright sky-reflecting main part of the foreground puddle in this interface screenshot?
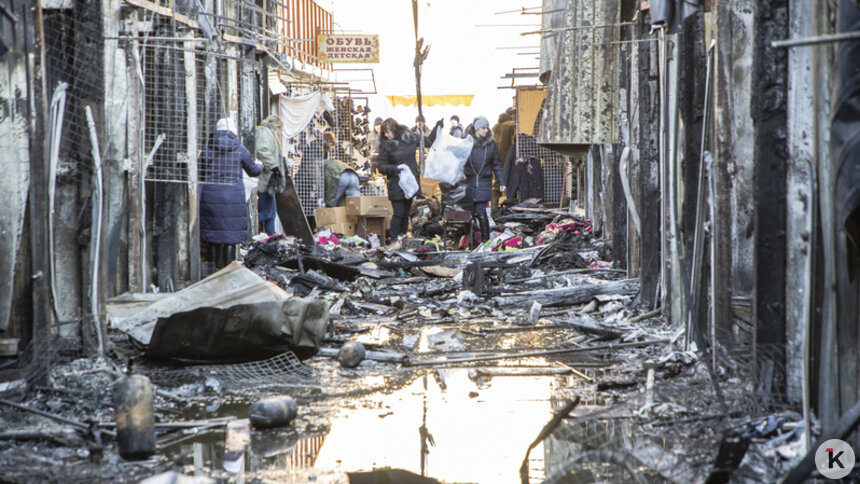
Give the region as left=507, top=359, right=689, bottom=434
left=315, top=369, right=554, bottom=483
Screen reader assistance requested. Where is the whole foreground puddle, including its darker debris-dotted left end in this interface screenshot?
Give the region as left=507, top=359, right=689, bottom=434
left=162, top=369, right=558, bottom=483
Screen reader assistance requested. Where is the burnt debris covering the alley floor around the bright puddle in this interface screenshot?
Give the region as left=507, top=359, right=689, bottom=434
left=0, top=210, right=803, bottom=482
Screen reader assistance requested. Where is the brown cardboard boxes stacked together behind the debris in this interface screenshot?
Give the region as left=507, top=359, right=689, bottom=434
left=314, top=196, right=393, bottom=240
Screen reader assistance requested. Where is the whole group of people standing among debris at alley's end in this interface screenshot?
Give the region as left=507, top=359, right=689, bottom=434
left=199, top=108, right=515, bottom=270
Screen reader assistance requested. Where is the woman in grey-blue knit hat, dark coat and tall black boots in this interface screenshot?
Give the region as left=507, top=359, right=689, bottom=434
left=463, top=116, right=505, bottom=241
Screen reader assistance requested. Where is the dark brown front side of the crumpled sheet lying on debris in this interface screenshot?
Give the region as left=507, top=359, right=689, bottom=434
left=146, top=297, right=329, bottom=360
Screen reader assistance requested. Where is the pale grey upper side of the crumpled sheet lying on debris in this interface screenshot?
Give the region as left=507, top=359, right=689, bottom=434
left=109, top=262, right=290, bottom=345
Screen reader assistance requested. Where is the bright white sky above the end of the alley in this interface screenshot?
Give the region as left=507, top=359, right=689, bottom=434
left=319, top=0, right=541, bottom=126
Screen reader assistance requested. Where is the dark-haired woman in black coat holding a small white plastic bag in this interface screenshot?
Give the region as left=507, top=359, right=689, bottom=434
left=379, top=118, right=439, bottom=240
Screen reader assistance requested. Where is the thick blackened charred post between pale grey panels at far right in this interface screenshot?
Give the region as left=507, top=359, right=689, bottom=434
left=752, top=0, right=789, bottom=405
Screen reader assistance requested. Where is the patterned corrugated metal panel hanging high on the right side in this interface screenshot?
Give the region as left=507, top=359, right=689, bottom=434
left=538, top=0, right=620, bottom=154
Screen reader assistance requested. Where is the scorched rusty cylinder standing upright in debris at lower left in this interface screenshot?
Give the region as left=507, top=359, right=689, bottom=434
left=113, top=375, right=155, bottom=460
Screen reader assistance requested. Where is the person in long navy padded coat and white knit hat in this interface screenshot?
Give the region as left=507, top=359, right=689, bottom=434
left=200, top=118, right=263, bottom=270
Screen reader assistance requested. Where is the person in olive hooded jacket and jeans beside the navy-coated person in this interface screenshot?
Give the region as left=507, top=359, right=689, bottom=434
left=254, top=114, right=288, bottom=235
